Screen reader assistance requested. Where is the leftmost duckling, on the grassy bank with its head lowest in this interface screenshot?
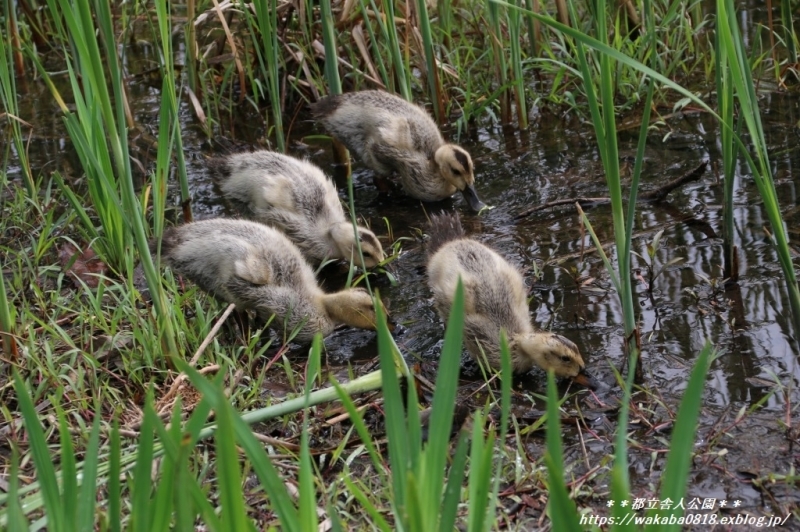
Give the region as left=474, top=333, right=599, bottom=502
left=151, top=218, right=388, bottom=343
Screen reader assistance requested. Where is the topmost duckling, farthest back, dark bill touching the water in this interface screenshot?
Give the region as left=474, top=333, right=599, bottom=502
left=311, top=91, right=486, bottom=211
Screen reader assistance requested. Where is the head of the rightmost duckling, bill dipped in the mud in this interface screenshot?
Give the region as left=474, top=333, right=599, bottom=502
left=511, top=332, right=588, bottom=382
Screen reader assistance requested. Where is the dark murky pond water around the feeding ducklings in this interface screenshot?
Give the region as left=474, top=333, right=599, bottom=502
left=10, top=14, right=800, bottom=513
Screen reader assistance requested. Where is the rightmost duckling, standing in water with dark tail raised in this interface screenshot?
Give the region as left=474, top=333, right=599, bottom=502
left=428, top=214, right=591, bottom=385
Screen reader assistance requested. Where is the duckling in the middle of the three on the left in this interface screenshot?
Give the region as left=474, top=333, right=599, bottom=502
left=209, top=150, right=385, bottom=268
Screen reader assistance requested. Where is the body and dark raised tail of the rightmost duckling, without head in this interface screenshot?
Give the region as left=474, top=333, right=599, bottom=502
left=428, top=215, right=531, bottom=334
